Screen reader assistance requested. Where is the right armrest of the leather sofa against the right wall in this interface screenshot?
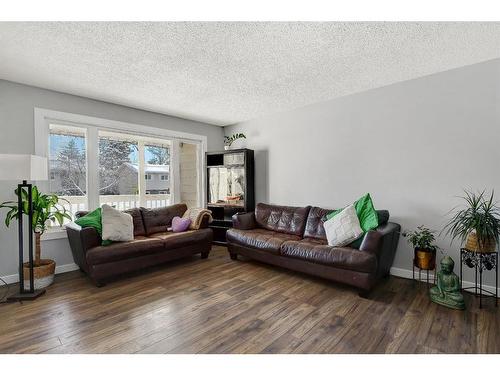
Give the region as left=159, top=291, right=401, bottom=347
left=359, top=222, right=401, bottom=277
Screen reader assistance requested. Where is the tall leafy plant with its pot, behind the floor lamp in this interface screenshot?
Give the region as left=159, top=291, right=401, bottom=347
left=0, top=186, right=71, bottom=289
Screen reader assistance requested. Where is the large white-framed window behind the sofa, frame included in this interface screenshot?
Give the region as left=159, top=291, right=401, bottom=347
left=35, top=108, right=206, bottom=228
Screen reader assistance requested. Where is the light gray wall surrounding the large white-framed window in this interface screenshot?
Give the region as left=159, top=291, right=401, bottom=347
left=0, top=80, right=223, bottom=276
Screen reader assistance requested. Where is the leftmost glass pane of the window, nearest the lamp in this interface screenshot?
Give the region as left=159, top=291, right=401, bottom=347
left=49, top=124, right=87, bottom=220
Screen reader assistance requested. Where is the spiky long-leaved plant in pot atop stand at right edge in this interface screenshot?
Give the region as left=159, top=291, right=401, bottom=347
left=444, top=190, right=500, bottom=253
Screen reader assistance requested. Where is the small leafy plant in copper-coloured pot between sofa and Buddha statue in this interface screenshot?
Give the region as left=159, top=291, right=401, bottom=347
left=403, top=225, right=438, bottom=270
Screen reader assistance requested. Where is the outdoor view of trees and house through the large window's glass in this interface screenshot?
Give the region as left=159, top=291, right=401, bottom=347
left=45, top=124, right=195, bottom=225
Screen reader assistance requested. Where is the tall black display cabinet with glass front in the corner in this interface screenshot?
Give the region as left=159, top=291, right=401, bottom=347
left=206, top=148, right=255, bottom=245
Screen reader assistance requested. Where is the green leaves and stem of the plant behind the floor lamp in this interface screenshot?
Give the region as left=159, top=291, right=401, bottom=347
left=0, top=186, right=71, bottom=265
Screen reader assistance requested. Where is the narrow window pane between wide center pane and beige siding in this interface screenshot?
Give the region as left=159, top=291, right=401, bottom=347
left=144, top=141, right=171, bottom=208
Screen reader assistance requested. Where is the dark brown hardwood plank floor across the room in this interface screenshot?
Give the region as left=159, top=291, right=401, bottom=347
left=0, top=247, right=500, bottom=353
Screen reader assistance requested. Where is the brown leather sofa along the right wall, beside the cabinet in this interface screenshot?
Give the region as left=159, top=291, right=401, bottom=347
left=226, top=203, right=401, bottom=294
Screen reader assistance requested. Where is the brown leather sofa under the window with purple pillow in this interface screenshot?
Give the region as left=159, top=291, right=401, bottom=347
left=66, top=204, right=212, bottom=286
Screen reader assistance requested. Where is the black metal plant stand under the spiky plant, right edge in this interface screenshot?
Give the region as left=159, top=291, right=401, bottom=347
left=460, top=248, right=498, bottom=309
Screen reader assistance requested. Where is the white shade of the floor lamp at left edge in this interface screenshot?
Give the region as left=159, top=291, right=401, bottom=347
left=0, top=154, right=48, bottom=181
